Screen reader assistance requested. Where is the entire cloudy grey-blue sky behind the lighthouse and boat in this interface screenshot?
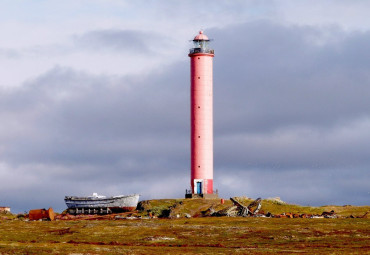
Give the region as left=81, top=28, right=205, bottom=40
left=0, top=0, right=370, bottom=212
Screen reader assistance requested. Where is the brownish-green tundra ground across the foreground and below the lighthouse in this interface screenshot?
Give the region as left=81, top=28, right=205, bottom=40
left=0, top=198, right=370, bottom=254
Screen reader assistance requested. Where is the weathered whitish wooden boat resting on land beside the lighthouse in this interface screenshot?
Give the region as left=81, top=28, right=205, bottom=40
left=64, top=193, right=140, bottom=214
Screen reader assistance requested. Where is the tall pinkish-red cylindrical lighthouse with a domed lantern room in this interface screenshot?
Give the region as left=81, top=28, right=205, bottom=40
left=185, top=31, right=217, bottom=198
